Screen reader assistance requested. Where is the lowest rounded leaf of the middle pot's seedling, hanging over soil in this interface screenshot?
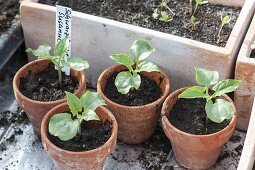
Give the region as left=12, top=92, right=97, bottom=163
left=115, top=71, right=141, bottom=94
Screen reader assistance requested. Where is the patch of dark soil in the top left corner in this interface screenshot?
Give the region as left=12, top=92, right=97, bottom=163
left=0, top=0, right=20, bottom=35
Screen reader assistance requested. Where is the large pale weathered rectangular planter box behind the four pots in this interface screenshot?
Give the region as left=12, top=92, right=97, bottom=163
left=21, top=0, right=255, bottom=90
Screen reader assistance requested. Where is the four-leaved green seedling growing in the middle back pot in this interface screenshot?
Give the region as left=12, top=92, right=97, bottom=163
left=110, top=39, right=160, bottom=94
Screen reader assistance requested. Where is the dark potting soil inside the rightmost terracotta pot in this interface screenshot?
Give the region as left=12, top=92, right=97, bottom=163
left=168, top=99, right=230, bottom=135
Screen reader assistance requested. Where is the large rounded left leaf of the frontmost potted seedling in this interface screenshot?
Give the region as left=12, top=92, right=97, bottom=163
left=49, top=113, right=80, bottom=141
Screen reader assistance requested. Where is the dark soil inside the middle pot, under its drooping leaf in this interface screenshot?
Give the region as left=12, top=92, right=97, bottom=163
left=104, top=72, right=162, bottom=106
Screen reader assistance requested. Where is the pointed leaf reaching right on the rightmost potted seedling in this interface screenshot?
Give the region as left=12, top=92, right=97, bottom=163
left=213, top=79, right=242, bottom=97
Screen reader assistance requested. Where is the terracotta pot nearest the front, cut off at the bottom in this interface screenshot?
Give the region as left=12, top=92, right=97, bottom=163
left=41, top=103, right=118, bottom=170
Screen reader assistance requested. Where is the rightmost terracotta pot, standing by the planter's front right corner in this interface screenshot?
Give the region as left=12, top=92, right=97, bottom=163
left=162, top=87, right=237, bottom=169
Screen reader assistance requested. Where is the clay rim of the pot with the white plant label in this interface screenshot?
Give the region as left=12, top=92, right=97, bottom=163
left=13, top=59, right=86, bottom=105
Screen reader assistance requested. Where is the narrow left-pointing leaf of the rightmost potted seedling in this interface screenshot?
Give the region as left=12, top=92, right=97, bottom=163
left=178, top=86, right=207, bottom=99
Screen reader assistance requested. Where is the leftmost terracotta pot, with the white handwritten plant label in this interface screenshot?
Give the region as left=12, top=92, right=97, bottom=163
left=13, top=60, right=86, bottom=135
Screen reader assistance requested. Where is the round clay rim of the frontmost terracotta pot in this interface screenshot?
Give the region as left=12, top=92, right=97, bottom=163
left=41, top=102, right=118, bottom=156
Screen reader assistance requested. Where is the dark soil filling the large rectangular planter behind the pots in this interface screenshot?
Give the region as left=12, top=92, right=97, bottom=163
left=39, top=0, right=241, bottom=47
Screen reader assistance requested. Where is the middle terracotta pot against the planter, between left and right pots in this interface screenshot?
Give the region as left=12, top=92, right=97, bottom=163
left=97, top=65, right=170, bottom=144
